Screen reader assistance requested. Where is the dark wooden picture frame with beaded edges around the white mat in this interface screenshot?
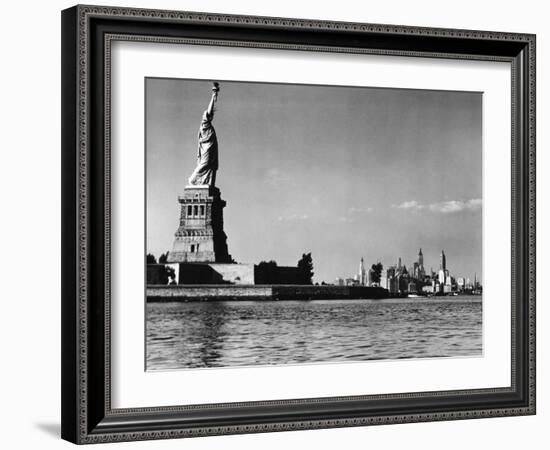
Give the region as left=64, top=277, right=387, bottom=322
left=62, top=6, right=535, bottom=443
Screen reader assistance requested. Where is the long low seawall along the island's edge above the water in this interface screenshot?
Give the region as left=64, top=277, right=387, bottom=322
left=147, top=284, right=389, bottom=302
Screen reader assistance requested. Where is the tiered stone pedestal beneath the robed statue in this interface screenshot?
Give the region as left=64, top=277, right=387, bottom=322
left=167, top=185, right=232, bottom=263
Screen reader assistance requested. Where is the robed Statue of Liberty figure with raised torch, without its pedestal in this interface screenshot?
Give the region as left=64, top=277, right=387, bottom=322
left=189, top=83, right=220, bottom=186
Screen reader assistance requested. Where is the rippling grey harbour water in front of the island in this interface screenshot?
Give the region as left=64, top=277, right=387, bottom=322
left=147, top=296, right=482, bottom=370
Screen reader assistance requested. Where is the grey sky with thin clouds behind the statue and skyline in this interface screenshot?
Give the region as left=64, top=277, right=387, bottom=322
left=145, top=78, right=482, bottom=282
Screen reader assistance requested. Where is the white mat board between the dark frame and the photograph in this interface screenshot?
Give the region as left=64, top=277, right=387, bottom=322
left=111, top=41, right=511, bottom=408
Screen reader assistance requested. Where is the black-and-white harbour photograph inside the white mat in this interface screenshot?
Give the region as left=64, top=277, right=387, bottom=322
left=144, top=78, right=483, bottom=371
